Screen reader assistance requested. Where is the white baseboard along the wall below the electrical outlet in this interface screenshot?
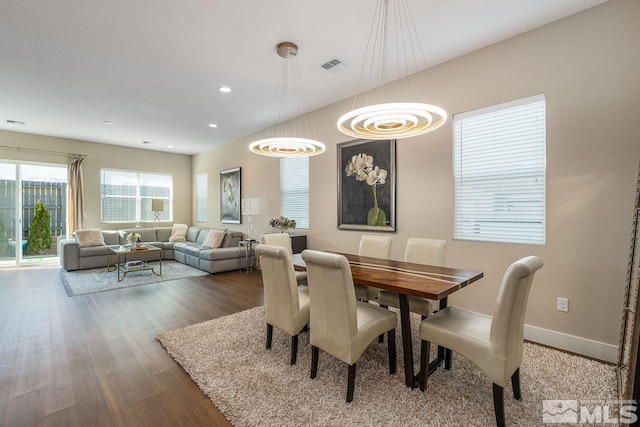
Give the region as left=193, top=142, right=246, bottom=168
left=524, top=325, right=618, bottom=363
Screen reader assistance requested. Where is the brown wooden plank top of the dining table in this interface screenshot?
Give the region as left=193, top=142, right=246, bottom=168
left=293, top=253, right=484, bottom=300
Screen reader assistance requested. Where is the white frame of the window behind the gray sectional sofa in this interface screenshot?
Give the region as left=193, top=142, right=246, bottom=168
left=100, top=168, right=173, bottom=224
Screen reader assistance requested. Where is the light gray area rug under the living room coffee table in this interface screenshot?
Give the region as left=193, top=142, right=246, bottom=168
left=60, top=261, right=209, bottom=297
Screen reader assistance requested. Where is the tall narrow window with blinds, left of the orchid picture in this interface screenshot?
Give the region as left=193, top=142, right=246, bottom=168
left=280, top=157, right=309, bottom=228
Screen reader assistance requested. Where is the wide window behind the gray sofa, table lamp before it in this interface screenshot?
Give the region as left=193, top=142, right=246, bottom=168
left=100, top=169, right=173, bottom=226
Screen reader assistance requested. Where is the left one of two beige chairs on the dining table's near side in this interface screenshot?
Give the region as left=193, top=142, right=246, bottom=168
left=255, top=244, right=310, bottom=365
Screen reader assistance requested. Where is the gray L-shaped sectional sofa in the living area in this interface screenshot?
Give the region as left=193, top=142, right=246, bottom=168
left=58, top=227, right=247, bottom=273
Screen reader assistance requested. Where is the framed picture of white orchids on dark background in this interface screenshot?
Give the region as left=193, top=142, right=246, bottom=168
left=338, top=139, right=396, bottom=231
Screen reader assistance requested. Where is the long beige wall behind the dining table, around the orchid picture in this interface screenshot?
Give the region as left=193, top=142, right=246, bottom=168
left=193, top=0, right=640, bottom=345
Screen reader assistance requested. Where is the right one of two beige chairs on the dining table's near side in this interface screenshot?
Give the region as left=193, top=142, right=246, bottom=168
left=302, top=249, right=398, bottom=402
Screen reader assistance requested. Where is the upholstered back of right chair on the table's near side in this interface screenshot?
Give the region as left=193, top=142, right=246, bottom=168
left=302, top=250, right=360, bottom=365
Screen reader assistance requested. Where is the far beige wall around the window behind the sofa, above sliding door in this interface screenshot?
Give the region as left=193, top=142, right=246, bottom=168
left=0, top=131, right=191, bottom=229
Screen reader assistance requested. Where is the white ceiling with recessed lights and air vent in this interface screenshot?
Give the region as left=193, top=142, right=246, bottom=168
left=0, top=0, right=606, bottom=154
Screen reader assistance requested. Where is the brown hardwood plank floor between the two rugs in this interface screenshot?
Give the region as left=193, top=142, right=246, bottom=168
left=0, top=266, right=263, bottom=426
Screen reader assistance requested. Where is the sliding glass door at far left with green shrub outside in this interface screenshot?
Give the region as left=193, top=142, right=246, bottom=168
left=0, top=162, right=67, bottom=266
